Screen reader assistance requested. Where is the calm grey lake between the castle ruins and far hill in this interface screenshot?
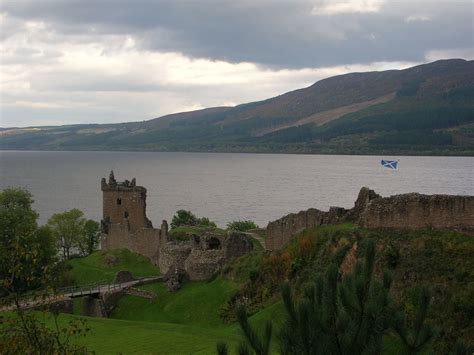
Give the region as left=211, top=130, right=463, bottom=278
left=0, top=151, right=474, bottom=226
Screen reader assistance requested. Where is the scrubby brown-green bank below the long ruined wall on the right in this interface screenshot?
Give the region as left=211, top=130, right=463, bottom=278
left=221, top=225, right=474, bottom=353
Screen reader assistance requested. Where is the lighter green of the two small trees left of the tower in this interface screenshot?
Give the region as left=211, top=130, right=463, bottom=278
left=48, top=208, right=86, bottom=259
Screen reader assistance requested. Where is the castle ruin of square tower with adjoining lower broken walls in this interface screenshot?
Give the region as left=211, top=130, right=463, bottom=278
left=101, top=172, right=253, bottom=280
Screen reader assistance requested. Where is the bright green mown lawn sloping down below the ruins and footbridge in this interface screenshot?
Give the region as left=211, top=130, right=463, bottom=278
left=61, top=278, right=284, bottom=354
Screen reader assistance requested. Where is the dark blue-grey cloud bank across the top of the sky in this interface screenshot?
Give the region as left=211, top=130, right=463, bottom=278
left=0, top=0, right=473, bottom=68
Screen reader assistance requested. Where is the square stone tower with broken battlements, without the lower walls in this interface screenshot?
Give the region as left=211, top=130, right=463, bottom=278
left=101, top=171, right=153, bottom=233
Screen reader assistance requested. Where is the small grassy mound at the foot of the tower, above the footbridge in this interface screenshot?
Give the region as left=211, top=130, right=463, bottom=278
left=69, top=249, right=160, bottom=285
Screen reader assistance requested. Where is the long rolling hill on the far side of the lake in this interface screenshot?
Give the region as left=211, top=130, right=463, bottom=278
left=0, top=59, right=474, bottom=155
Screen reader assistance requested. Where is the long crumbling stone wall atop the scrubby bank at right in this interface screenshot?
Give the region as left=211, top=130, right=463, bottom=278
left=265, top=187, right=474, bottom=250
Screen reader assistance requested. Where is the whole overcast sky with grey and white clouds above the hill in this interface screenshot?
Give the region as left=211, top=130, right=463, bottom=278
left=0, top=0, right=474, bottom=127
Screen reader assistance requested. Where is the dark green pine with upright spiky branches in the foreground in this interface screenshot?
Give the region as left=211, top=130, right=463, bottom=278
left=279, top=243, right=393, bottom=354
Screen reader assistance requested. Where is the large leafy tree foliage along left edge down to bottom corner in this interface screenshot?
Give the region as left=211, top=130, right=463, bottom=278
left=0, top=188, right=87, bottom=354
